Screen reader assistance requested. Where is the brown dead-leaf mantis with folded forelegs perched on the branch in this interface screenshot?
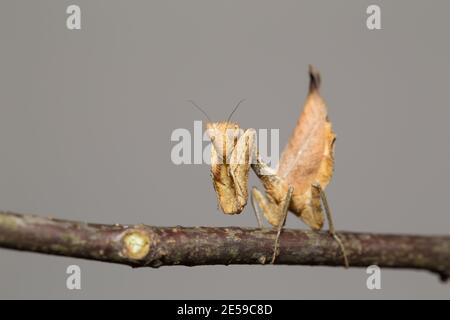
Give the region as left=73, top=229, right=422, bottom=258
left=190, top=66, right=349, bottom=267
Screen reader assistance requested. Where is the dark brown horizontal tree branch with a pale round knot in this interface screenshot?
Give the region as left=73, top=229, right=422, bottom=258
left=0, top=212, right=450, bottom=280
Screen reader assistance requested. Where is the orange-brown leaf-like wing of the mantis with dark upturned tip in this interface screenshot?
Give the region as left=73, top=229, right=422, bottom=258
left=278, top=66, right=336, bottom=194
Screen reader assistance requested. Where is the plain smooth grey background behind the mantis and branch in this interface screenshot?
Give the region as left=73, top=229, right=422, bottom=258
left=0, top=0, right=450, bottom=298
